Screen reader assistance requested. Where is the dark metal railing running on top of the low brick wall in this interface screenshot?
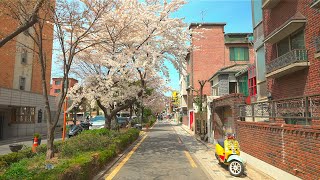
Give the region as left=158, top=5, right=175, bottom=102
left=239, top=94, right=320, bottom=124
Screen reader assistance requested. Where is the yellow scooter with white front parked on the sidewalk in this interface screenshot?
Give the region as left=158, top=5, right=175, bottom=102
left=215, top=134, right=244, bottom=177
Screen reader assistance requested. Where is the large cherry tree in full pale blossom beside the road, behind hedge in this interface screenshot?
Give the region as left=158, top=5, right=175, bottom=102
left=70, top=0, right=189, bottom=128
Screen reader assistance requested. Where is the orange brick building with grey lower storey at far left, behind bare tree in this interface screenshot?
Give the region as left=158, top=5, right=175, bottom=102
left=0, top=1, right=56, bottom=139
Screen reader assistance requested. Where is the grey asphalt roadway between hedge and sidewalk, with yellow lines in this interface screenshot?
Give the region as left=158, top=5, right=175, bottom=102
left=105, top=122, right=209, bottom=180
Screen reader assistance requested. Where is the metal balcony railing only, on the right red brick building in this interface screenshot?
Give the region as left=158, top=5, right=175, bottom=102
left=266, top=49, right=308, bottom=73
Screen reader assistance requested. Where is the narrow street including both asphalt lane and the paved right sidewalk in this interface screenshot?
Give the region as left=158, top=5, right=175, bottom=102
left=101, top=121, right=269, bottom=180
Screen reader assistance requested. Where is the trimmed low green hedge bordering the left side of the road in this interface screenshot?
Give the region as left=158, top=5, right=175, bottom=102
left=0, top=129, right=139, bottom=180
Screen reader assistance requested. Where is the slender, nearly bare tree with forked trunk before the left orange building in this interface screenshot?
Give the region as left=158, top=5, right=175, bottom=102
left=0, top=0, right=114, bottom=159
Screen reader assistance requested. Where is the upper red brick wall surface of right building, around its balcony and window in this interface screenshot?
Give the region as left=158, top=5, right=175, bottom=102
left=263, top=0, right=320, bottom=99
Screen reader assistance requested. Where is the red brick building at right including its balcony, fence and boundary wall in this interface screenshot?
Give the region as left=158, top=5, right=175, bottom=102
left=237, top=0, right=320, bottom=179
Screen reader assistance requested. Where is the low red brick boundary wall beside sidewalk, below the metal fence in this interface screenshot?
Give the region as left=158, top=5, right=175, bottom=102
left=237, top=121, right=320, bottom=180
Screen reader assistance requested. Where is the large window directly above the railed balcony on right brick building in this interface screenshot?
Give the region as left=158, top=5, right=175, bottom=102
left=277, top=30, right=306, bottom=57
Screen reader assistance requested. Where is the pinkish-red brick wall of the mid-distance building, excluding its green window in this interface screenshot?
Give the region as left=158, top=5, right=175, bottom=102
left=187, top=25, right=255, bottom=95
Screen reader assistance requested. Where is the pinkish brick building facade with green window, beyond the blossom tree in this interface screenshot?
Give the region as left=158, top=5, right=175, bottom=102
left=185, top=23, right=254, bottom=129
